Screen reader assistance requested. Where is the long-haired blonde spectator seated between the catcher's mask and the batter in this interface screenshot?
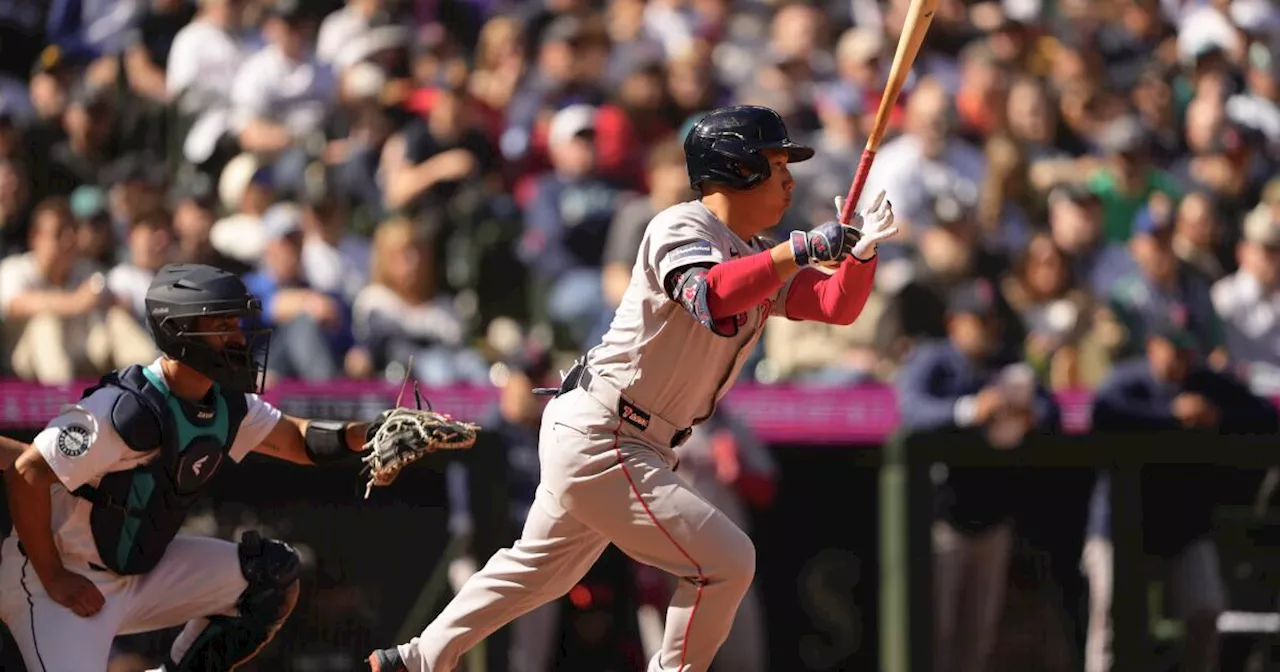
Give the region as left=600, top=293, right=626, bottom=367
left=353, top=219, right=489, bottom=387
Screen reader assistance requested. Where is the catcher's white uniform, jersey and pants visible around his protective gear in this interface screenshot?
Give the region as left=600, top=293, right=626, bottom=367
left=0, top=361, right=280, bottom=672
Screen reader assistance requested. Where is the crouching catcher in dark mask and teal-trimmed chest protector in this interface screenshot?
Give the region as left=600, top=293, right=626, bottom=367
left=0, top=265, right=471, bottom=672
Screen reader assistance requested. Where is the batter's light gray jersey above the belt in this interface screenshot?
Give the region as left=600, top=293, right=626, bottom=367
left=586, top=201, right=790, bottom=428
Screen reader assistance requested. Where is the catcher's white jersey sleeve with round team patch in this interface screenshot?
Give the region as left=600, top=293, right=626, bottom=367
left=31, top=388, right=135, bottom=490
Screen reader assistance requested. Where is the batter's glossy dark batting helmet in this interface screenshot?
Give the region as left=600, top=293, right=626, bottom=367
left=685, top=105, right=813, bottom=189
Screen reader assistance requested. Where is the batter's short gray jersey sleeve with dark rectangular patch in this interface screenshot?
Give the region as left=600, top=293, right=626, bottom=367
left=641, top=201, right=732, bottom=288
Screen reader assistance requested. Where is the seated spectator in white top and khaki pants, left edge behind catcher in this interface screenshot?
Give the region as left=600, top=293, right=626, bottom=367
left=0, top=198, right=155, bottom=384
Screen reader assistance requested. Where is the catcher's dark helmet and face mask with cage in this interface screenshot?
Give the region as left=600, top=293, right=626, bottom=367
left=146, top=264, right=271, bottom=393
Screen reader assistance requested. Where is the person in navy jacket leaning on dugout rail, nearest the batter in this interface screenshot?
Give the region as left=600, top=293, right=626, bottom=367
left=896, top=280, right=1060, bottom=672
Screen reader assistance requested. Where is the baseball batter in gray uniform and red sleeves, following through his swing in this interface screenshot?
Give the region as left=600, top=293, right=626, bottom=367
left=369, top=106, right=897, bottom=672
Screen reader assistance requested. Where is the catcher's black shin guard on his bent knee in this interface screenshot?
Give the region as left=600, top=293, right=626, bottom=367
left=166, top=531, right=301, bottom=672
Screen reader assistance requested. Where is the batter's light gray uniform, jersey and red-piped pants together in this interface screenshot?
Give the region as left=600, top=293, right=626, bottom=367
left=398, top=201, right=808, bottom=672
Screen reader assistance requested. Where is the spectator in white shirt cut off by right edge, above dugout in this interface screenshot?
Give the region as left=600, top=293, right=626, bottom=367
left=1213, top=204, right=1280, bottom=396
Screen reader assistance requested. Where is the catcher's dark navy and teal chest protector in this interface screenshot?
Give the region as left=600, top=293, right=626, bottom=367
left=74, top=366, right=248, bottom=575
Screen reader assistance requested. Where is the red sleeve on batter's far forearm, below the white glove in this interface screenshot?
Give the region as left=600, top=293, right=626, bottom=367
left=786, top=256, right=879, bottom=324
